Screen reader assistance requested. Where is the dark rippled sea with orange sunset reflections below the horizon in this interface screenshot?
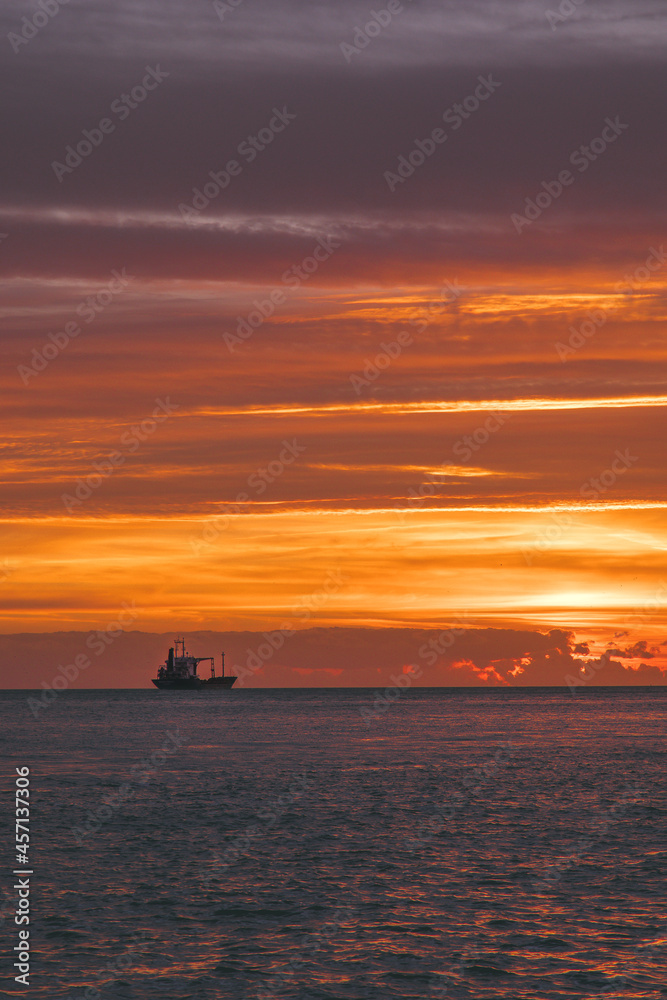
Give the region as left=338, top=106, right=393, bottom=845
left=0, top=688, right=667, bottom=1000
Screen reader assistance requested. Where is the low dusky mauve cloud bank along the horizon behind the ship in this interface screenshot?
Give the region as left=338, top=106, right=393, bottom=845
left=0, top=626, right=665, bottom=689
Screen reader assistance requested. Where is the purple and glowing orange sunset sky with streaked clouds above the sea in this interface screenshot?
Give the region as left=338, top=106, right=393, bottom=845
left=0, top=0, right=667, bottom=687
